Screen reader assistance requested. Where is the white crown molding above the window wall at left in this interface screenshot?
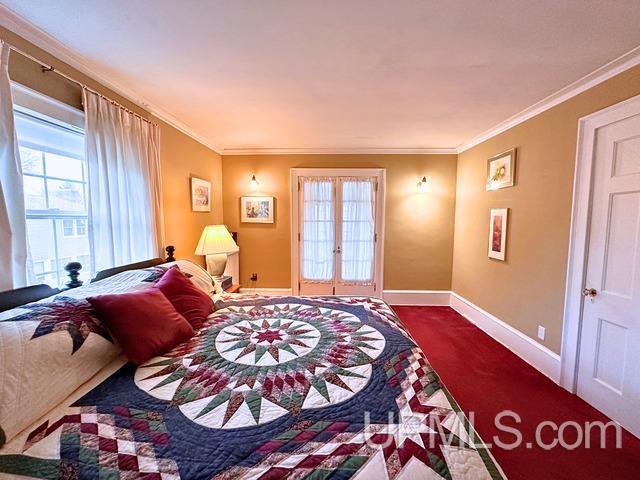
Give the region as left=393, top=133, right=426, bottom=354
left=0, top=5, right=222, bottom=154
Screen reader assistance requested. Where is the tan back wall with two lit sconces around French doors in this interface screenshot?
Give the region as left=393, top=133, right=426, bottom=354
left=222, top=155, right=456, bottom=290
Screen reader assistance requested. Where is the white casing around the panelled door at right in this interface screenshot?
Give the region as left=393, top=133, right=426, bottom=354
left=560, top=95, right=640, bottom=393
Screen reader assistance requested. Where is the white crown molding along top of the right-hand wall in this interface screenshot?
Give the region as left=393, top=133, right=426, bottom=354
left=456, top=46, right=640, bottom=153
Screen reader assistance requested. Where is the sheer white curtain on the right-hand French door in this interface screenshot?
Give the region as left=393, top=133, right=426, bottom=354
left=341, top=179, right=375, bottom=282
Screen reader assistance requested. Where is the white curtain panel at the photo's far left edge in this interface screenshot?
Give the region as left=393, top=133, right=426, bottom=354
left=0, top=42, right=27, bottom=291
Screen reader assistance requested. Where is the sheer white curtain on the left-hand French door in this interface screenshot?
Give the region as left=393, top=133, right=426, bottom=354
left=301, top=177, right=335, bottom=281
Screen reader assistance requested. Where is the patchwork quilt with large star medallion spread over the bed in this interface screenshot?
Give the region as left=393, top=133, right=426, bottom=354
left=0, top=295, right=502, bottom=479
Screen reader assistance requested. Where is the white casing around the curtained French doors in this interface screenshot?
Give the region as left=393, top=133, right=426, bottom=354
left=289, top=168, right=387, bottom=298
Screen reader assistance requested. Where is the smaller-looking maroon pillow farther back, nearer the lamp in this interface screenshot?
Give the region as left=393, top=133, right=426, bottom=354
left=155, top=268, right=213, bottom=330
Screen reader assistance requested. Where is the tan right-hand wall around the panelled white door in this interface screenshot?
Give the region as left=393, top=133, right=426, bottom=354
left=452, top=67, right=640, bottom=353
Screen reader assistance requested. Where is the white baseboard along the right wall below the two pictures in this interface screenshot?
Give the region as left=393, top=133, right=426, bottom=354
left=450, top=292, right=560, bottom=383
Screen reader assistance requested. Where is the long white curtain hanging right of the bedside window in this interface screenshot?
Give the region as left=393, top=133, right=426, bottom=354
left=83, top=89, right=164, bottom=272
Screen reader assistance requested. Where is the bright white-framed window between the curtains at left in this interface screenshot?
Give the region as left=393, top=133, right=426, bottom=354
left=14, top=92, right=90, bottom=287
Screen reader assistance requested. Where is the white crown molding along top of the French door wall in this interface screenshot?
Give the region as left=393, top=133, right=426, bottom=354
left=222, top=147, right=457, bottom=155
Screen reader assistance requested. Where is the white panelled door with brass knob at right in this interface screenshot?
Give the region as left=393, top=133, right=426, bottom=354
left=578, top=115, right=640, bottom=436
